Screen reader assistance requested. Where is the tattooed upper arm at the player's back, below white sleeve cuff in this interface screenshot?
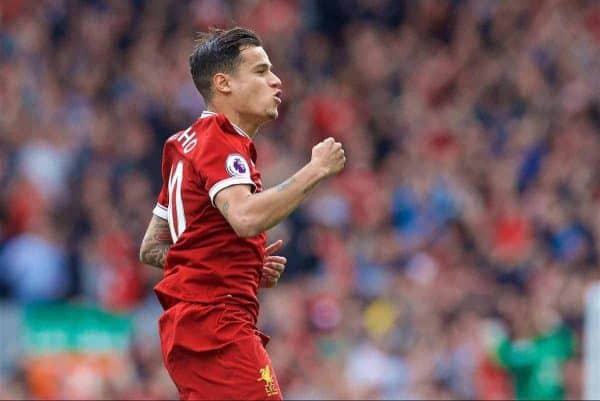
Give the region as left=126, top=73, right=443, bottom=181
left=140, top=215, right=173, bottom=269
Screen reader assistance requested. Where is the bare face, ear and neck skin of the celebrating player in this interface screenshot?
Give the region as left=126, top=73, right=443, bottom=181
left=208, top=46, right=282, bottom=136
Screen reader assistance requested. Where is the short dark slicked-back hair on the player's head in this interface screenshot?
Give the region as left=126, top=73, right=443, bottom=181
left=190, top=26, right=262, bottom=102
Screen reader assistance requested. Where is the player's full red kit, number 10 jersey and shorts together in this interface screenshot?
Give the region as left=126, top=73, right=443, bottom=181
left=154, top=112, right=281, bottom=400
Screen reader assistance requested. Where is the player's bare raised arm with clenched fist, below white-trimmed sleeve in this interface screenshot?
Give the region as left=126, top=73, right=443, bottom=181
left=215, top=138, right=346, bottom=237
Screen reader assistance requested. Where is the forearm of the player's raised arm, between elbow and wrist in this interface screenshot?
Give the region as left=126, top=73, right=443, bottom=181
left=240, top=164, right=325, bottom=234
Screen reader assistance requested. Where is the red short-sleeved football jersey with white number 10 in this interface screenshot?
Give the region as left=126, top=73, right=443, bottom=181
left=153, top=112, right=266, bottom=319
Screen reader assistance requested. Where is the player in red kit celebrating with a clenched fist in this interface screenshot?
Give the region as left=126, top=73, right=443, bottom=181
left=140, top=28, right=346, bottom=400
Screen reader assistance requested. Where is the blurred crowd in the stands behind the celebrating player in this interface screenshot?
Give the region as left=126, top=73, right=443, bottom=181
left=0, top=0, right=600, bottom=399
